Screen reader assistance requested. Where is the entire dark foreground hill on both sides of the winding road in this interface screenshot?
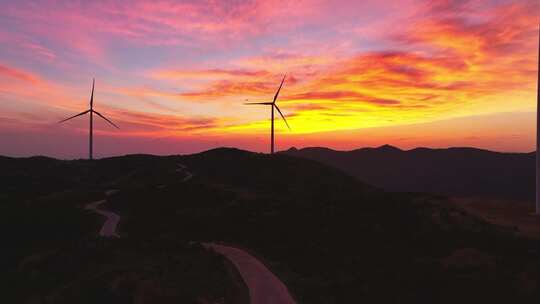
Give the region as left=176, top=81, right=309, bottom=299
left=0, top=147, right=540, bottom=304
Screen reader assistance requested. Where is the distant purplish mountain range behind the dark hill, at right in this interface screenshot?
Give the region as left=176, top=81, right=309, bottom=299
left=280, top=145, right=536, bottom=200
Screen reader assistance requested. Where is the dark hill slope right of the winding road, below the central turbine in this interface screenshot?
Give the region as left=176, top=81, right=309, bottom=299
left=102, top=149, right=540, bottom=303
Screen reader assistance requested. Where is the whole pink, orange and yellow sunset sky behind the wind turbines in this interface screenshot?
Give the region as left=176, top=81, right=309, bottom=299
left=0, top=0, right=540, bottom=158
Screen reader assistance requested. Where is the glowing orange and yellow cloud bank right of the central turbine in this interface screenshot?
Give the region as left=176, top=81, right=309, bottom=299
left=194, top=2, right=539, bottom=133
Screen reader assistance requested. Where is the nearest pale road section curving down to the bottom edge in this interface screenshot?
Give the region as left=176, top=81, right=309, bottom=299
left=203, top=243, right=296, bottom=304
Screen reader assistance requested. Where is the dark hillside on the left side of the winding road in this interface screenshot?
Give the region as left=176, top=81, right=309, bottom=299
left=0, top=155, right=247, bottom=304
